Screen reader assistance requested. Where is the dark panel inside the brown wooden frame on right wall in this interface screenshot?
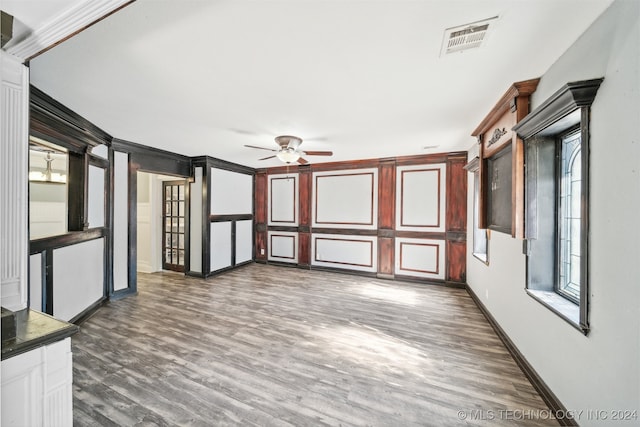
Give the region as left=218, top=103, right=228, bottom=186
left=485, top=145, right=513, bottom=234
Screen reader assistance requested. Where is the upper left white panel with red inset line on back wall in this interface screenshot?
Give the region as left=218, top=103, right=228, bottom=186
left=268, top=173, right=298, bottom=226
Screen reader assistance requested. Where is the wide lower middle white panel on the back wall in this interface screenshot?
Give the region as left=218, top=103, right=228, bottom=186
left=311, top=234, right=378, bottom=272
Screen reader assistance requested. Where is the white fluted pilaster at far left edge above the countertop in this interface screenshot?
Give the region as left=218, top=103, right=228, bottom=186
left=0, top=52, right=29, bottom=311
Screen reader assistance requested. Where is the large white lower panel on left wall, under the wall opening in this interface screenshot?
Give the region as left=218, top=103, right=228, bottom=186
left=53, top=238, right=105, bottom=321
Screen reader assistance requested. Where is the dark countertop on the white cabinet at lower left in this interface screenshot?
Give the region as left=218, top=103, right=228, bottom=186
left=2, top=309, right=79, bottom=360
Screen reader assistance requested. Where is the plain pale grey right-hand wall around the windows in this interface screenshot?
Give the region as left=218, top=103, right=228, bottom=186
left=467, top=0, right=640, bottom=426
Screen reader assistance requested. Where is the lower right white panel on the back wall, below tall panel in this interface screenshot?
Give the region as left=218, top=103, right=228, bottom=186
left=395, top=238, right=446, bottom=280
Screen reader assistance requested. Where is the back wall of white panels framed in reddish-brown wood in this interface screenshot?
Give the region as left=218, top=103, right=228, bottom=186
left=255, top=153, right=467, bottom=286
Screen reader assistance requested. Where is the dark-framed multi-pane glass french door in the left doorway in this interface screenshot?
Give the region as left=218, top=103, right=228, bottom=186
left=162, top=181, right=185, bottom=272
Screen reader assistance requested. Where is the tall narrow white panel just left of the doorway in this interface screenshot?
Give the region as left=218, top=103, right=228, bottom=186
left=113, top=151, right=129, bottom=291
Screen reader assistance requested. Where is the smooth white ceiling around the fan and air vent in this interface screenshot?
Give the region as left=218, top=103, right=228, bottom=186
left=2, top=0, right=612, bottom=167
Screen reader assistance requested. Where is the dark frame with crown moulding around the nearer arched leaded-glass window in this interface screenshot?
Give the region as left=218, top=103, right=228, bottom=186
left=513, top=78, right=604, bottom=335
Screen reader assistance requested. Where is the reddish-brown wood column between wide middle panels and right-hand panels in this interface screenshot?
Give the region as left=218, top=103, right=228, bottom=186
left=378, top=159, right=396, bottom=279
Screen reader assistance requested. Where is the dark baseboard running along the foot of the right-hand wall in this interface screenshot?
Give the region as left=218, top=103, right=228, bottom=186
left=466, top=285, right=578, bottom=426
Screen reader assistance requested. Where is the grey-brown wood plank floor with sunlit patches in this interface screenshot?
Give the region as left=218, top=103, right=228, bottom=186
left=72, top=264, right=557, bottom=426
